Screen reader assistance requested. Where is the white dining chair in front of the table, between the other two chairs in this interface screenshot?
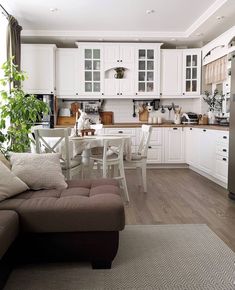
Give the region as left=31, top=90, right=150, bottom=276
left=90, top=137, right=130, bottom=202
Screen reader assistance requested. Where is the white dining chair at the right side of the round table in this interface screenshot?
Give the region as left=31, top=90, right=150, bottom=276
left=124, top=125, right=152, bottom=192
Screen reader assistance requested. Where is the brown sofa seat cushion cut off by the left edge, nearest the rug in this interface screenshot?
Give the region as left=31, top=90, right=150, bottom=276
left=0, top=210, right=19, bottom=259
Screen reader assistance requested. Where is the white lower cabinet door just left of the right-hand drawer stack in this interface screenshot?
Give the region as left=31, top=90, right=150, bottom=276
left=198, top=129, right=217, bottom=175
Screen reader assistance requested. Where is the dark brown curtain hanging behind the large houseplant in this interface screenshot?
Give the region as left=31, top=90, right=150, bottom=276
left=7, top=15, right=22, bottom=70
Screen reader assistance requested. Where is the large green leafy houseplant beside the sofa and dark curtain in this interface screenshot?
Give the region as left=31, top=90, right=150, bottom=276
left=0, top=59, right=49, bottom=155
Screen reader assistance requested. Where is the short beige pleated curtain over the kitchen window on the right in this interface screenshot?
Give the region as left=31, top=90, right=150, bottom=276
left=205, top=56, right=227, bottom=85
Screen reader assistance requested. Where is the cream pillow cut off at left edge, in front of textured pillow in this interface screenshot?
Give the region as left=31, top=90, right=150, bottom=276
left=0, top=162, right=29, bottom=201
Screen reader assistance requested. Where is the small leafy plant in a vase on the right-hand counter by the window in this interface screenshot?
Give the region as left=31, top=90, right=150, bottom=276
left=203, top=89, right=224, bottom=124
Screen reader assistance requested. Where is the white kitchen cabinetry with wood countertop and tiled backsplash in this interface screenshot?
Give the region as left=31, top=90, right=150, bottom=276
left=19, top=27, right=235, bottom=193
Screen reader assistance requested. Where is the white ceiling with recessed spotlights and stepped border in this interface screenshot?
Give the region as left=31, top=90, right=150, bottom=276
left=1, top=0, right=235, bottom=46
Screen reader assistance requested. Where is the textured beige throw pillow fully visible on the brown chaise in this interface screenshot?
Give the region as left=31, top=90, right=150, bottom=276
left=10, top=153, right=68, bottom=190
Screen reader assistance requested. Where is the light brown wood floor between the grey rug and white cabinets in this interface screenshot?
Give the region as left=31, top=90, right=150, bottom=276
left=125, top=169, right=235, bottom=251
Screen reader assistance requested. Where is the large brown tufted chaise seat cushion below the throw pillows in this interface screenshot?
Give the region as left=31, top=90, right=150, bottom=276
left=0, top=179, right=125, bottom=232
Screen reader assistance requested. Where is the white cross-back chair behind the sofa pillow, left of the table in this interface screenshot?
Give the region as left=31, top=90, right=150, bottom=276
left=34, top=128, right=71, bottom=168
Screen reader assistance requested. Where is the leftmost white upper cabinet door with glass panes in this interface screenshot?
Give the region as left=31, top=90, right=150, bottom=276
left=78, top=44, right=104, bottom=96
